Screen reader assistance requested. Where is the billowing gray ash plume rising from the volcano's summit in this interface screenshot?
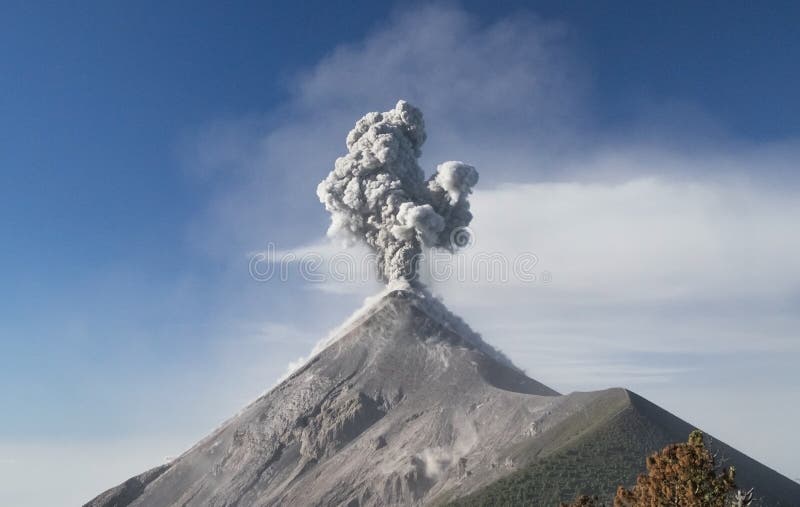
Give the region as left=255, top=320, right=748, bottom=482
left=317, top=100, right=478, bottom=281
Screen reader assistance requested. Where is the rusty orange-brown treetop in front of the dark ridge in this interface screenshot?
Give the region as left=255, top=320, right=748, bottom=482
left=614, top=430, right=736, bottom=507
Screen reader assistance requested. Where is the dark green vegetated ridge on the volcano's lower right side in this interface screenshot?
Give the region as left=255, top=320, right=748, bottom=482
left=440, top=389, right=800, bottom=507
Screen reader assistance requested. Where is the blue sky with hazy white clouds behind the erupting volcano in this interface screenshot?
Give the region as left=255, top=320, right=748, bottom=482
left=0, top=2, right=800, bottom=505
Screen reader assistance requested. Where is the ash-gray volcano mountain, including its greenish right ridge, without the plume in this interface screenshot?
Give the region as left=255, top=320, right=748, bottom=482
left=87, top=290, right=800, bottom=507
